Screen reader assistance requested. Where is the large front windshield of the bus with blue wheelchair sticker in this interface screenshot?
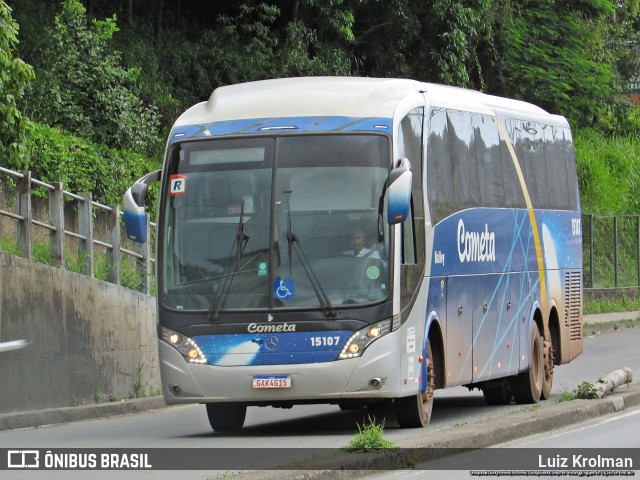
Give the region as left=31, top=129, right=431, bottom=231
left=159, top=134, right=390, bottom=319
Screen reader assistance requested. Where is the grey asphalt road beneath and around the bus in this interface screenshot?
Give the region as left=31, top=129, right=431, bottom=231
left=0, top=328, right=640, bottom=479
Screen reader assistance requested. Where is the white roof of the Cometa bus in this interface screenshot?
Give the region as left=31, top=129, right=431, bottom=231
left=175, top=77, right=566, bottom=126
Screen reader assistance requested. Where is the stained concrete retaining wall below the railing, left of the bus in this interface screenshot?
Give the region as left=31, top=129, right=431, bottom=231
left=0, top=253, right=160, bottom=413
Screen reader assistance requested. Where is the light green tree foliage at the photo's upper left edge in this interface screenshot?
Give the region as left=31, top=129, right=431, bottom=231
left=0, top=0, right=33, bottom=168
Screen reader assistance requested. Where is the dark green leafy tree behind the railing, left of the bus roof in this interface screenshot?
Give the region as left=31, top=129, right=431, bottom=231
left=28, top=0, right=158, bottom=153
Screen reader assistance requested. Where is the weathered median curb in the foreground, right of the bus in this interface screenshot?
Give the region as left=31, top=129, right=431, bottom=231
left=233, top=384, right=640, bottom=480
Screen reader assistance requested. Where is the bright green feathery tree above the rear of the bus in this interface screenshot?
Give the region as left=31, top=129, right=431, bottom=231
left=485, top=0, right=615, bottom=125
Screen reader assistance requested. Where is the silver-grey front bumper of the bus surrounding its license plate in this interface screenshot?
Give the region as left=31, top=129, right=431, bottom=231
left=159, top=335, right=404, bottom=405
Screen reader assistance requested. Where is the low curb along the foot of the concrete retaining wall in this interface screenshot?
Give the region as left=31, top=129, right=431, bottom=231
left=0, top=396, right=165, bottom=431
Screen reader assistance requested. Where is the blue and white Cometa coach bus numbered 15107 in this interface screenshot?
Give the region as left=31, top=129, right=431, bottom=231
left=125, top=77, right=583, bottom=431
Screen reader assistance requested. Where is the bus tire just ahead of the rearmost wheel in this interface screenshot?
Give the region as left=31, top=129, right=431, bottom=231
left=509, top=322, right=544, bottom=404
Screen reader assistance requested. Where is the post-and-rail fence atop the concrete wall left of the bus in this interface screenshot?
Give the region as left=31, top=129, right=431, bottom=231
left=0, top=167, right=156, bottom=293
